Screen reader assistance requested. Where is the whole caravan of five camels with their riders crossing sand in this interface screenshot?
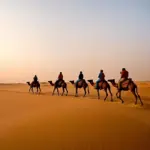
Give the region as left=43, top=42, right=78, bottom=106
left=27, top=68, right=143, bottom=105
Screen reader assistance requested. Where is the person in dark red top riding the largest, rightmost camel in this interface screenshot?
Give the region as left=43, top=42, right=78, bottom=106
left=118, top=68, right=129, bottom=90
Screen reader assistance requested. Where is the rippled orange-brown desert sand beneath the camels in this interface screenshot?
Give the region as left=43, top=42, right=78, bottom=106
left=0, top=82, right=150, bottom=150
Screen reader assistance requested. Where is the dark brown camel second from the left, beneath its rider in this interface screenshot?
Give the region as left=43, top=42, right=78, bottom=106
left=48, top=81, right=68, bottom=96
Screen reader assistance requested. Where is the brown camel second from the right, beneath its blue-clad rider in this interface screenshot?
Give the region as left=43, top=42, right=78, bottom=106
left=88, top=80, right=113, bottom=101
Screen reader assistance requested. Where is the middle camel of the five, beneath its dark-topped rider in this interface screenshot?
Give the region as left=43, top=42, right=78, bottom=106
left=70, top=80, right=90, bottom=97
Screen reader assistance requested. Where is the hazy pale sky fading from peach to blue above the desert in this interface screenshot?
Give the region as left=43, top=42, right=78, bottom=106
left=0, top=0, right=150, bottom=82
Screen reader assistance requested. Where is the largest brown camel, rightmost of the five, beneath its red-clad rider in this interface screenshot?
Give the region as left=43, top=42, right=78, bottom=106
left=108, top=78, right=143, bottom=105
